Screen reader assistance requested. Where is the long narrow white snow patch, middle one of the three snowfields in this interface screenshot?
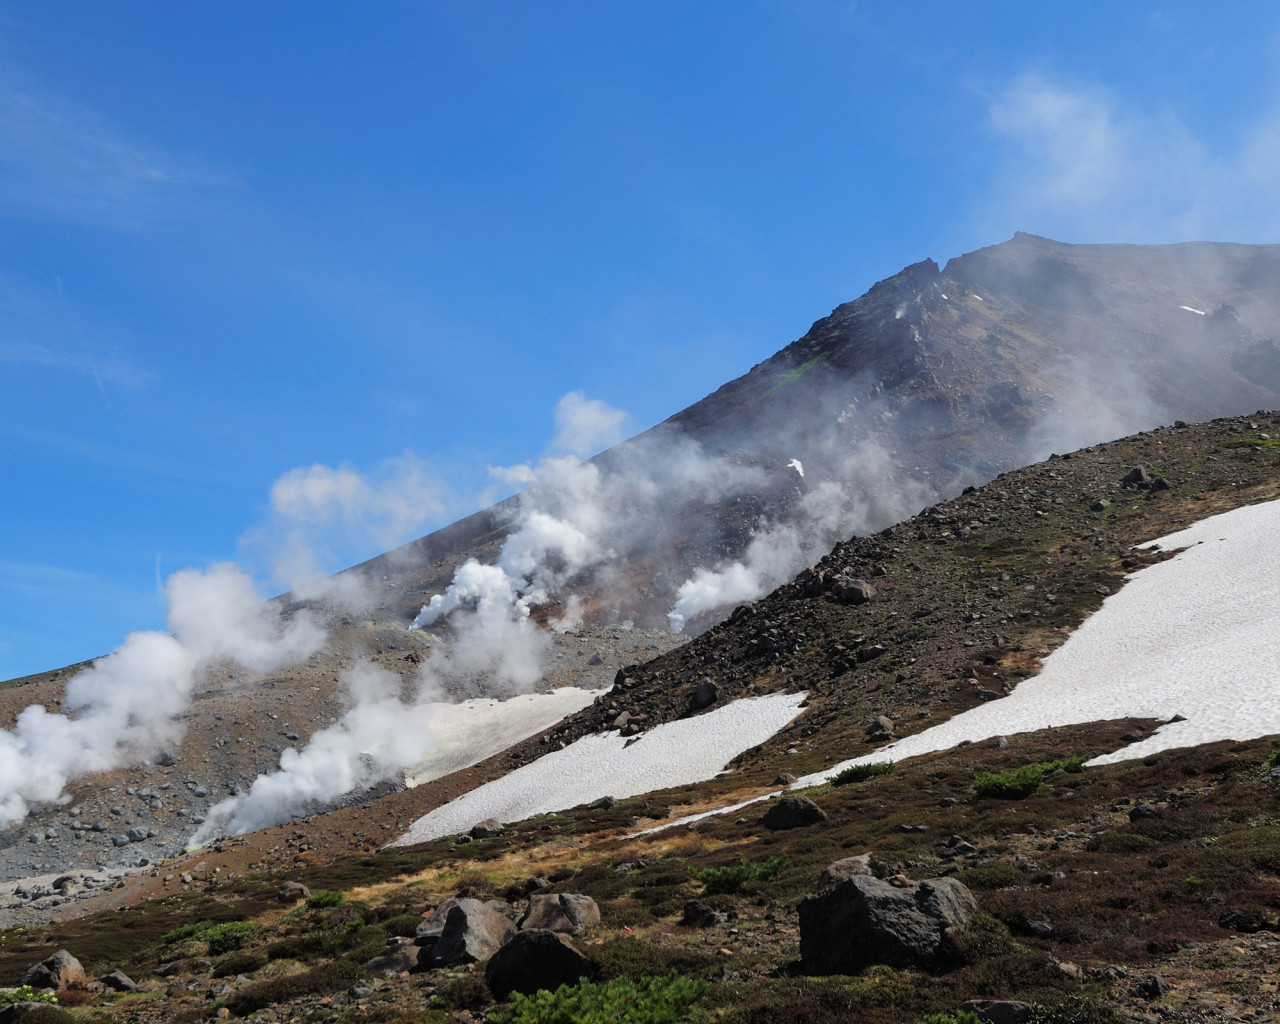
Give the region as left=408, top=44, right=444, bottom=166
left=389, top=692, right=808, bottom=846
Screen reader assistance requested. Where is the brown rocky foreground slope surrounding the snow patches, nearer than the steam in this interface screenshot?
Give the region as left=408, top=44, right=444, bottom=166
left=0, top=413, right=1280, bottom=1021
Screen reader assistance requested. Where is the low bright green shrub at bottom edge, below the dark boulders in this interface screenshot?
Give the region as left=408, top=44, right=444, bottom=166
left=490, top=972, right=707, bottom=1024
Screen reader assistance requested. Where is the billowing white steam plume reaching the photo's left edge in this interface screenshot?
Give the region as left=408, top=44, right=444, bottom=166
left=0, top=564, right=324, bottom=828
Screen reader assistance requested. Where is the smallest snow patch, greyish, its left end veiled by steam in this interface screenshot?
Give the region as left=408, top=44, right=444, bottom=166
left=404, top=686, right=608, bottom=788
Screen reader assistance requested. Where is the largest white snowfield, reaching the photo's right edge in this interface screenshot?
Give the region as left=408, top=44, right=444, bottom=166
left=796, top=502, right=1280, bottom=786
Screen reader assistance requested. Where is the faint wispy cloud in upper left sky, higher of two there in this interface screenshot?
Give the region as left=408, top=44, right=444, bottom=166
left=0, top=73, right=234, bottom=232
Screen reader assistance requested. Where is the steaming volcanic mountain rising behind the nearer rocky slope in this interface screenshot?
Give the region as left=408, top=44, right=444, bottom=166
left=0, top=234, right=1280, bottom=878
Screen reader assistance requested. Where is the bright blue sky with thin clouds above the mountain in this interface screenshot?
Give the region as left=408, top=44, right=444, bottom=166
left=0, top=0, right=1280, bottom=678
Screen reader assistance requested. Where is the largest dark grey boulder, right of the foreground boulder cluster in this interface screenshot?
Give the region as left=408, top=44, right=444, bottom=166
left=797, top=876, right=978, bottom=974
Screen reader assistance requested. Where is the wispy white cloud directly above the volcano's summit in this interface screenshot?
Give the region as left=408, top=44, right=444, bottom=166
left=979, top=73, right=1280, bottom=242
